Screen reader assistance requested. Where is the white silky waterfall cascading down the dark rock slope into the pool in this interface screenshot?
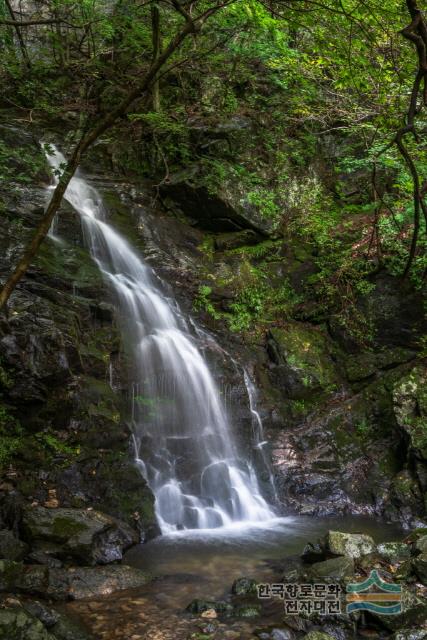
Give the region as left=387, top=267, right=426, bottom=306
left=48, top=146, right=274, bottom=532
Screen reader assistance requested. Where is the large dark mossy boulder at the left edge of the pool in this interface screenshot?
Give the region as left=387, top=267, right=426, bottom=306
left=22, top=507, right=139, bottom=565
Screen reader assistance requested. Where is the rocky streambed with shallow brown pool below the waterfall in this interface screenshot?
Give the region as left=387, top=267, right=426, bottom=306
left=0, top=507, right=427, bottom=640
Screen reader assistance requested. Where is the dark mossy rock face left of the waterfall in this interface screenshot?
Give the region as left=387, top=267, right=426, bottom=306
left=0, top=124, right=158, bottom=539
